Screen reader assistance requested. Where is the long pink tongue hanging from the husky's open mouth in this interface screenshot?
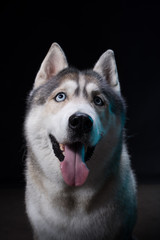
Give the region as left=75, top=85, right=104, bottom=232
left=61, top=143, right=89, bottom=186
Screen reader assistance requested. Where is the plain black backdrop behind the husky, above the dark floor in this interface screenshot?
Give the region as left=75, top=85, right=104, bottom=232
left=0, top=0, right=160, bottom=185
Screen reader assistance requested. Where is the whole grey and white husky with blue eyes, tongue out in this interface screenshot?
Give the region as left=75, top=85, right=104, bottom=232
left=25, top=43, right=136, bottom=240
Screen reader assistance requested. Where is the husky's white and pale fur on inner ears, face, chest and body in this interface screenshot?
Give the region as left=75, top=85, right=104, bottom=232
left=25, top=44, right=136, bottom=240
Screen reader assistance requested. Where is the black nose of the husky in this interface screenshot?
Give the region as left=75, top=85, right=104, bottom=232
left=69, top=112, right=93, bottom=133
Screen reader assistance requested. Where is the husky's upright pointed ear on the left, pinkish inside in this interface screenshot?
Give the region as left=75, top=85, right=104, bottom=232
left=34, top=43, right=68, bottom=88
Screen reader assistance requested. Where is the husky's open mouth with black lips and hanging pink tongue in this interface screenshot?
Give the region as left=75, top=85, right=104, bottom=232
left=49, top=134, right=95, bottom=186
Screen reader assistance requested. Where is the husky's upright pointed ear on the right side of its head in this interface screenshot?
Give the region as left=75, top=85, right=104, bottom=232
left=93, top=50, right=120, bottom=94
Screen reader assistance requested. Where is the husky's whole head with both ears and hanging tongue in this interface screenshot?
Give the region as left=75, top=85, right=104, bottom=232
left=25, top=44, right=124, bottom=186
